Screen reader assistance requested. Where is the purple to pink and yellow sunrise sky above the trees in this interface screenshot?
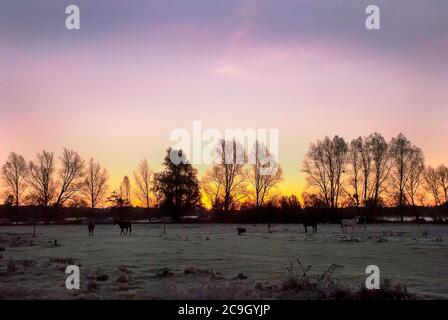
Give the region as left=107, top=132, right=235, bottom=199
left=0, top=0, right=448, bottom=200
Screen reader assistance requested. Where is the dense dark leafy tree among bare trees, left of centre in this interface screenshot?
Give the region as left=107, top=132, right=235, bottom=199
left=153, top=148, right=201, bottom=221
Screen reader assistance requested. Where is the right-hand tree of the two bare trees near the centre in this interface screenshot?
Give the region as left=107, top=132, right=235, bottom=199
left=250, top=140, right=283, bottom=208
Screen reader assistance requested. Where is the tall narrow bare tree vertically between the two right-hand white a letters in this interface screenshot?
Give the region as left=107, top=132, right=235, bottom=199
left=366, top=132, right=390, bottom=210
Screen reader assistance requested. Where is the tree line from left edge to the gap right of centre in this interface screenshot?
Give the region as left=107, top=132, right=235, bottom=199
left=1, top=140, right=282, bottom=217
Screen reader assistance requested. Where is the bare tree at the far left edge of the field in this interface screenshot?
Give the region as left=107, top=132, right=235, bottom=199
left=1, top=152, right=28, bottom=207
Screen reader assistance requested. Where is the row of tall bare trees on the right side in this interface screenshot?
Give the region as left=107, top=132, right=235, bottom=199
left=302, top=132, right=448, bottom=219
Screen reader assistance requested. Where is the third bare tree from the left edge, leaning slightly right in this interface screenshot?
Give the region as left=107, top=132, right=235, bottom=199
left=54, top=148, right=84, bottom=206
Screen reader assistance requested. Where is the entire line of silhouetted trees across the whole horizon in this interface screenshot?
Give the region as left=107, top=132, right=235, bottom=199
left=1, top=133, right=448, bottom=218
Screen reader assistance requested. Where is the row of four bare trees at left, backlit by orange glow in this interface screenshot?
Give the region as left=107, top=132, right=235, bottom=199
left=1, top=149, right=109, bottom=208
